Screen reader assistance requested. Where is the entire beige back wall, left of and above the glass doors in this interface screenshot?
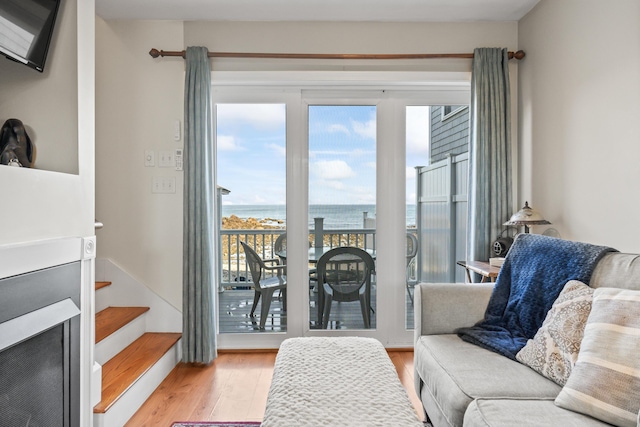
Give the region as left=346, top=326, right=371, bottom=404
left=96, top=19, right=517, bottom=310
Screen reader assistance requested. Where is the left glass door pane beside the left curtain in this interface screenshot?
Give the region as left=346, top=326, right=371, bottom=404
left=215, top=103, right=287, bottom=334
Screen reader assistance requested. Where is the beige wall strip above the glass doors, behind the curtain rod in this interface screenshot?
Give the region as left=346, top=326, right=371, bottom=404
left=185, top=21, right=517, bottom=71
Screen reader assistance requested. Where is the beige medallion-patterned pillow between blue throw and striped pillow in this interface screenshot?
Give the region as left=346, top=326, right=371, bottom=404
left=516, top=280, right=593, bottom=385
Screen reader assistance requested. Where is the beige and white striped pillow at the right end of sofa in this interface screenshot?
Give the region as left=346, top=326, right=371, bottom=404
left=555, top=288, right=640, bottom=427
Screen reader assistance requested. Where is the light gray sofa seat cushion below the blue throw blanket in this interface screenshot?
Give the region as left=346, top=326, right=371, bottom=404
left=414, top=334, right=561, bottom=426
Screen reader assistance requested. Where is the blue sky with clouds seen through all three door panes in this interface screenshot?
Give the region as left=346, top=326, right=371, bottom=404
left=217, top=104, right=429, bottom=205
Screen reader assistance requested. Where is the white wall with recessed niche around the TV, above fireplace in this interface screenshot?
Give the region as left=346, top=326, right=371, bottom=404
left=0, top=0, right=95, bottom=244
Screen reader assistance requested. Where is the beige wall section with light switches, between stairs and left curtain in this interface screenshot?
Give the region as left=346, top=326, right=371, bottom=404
left=96, top=18, right=184, bottom=308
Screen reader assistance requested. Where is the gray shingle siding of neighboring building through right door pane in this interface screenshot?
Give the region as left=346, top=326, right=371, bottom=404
left=431, top=106, right=469, bottom=163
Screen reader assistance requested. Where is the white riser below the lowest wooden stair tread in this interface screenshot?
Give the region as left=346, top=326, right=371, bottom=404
left=93, top=340, right=182, bottom=427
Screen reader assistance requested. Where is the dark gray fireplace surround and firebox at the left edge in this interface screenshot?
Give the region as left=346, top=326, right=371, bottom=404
left=0, top=262, right=81, bottom=427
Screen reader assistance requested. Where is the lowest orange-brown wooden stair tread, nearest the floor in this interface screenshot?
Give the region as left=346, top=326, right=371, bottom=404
left=93, top=332, right=182, bottom=413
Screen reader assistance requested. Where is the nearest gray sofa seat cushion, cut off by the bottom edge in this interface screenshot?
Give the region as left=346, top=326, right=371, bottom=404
left=463, top=399, right=609, bottom=427
